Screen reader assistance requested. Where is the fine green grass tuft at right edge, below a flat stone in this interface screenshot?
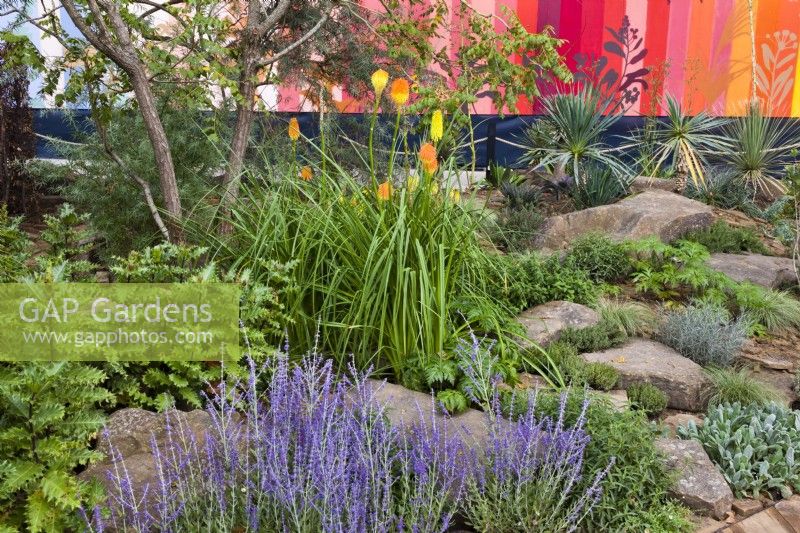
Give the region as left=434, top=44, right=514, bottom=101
left=732, top=283, right=800, bottom=332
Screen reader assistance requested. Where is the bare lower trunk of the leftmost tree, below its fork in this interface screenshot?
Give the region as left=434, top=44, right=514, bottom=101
left=128, top=68, right=183, bottom=243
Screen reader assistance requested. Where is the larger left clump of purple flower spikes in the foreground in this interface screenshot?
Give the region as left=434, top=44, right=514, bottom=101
left=83, top=355, right=468, bottom=531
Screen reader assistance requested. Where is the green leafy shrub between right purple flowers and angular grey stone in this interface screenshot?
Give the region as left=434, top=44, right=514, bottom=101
left=532, top=392, right=692, bottom=533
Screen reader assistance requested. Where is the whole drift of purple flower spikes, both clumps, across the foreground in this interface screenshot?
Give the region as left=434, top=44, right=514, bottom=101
left=82, top=348, right=607, bottom=533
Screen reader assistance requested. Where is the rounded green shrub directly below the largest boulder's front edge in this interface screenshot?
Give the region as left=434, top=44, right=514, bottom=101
left=564, top=234, right=631, bottom=282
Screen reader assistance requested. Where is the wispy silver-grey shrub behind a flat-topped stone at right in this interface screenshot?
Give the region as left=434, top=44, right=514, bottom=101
left=658, top=305, right=749, bottom=366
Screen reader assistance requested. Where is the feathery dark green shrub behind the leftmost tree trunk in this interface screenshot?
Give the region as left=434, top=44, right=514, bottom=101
left=36, top=105, right=226, bottom=255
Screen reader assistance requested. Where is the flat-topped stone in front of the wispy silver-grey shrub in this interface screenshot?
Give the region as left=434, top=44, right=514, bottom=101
left=583, top=339, right=709, bottom=412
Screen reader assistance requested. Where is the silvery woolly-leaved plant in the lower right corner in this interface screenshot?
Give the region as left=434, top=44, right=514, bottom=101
left=678, top=403, right=800, bottom=498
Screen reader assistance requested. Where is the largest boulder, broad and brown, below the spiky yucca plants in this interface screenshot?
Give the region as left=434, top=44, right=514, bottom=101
left=535, top=189, right=714, bottom=250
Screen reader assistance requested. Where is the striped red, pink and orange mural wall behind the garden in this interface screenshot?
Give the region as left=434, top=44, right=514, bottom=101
left=9, top=0, right=800, bottom=117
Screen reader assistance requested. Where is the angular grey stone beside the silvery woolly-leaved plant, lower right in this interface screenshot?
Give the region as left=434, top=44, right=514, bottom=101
left=656, top=439, right=733, bottom=519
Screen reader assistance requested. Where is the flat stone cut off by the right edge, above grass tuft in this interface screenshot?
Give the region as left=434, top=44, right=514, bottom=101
left=708, top=254, right=797, bottom=288
